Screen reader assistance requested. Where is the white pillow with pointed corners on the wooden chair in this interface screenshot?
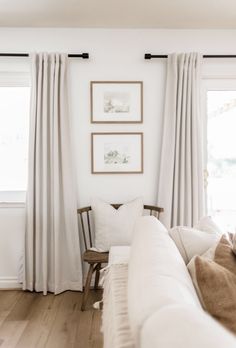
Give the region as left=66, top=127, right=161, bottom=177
left=92, top=198, right=143, bottom=251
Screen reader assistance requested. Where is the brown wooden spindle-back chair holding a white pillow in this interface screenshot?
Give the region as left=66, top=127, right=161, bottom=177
left=77, top=204, right=164, bottom=311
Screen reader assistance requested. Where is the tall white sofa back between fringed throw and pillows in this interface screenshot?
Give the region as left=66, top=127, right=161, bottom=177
left=128, top=216, right=201, bottom=338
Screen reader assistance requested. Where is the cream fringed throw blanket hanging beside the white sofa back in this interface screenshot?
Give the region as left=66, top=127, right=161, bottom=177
left=102, top=264, right=135, bottom=348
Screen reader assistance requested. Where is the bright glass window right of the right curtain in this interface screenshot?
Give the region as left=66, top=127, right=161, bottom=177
left=202, top=80, right=236, bottom=231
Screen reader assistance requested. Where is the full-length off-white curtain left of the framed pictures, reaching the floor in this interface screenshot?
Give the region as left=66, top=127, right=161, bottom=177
left=23, top=53, right=82, bottom=294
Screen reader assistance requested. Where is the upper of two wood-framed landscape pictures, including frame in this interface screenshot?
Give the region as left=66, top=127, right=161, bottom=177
left=90, top=81, right=143, bottom=123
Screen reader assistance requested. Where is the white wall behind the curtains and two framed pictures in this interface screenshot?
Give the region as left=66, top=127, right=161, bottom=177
left=0, top=29, right=236, bottom=286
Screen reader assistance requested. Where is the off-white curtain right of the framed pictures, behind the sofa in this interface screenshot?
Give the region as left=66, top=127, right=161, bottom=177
left=158, top=53, right=204, bottom=228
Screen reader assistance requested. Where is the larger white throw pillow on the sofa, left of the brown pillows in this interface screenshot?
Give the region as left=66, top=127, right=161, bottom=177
left=169, top=226, right=221, bottom=264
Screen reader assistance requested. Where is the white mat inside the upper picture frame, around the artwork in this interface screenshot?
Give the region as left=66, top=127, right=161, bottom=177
left=92, top=82, right=142, bottom=122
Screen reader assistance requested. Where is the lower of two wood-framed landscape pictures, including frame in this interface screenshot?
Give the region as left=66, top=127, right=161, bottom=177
left=91, top=133, right=143, bottom=174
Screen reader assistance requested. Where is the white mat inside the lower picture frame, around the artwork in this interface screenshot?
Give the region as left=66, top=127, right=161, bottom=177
left=92, top=133, right=142, bottom=173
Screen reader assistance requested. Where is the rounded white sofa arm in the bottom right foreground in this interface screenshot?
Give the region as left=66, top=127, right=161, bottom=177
left=140, top=304, right=236, bottom=348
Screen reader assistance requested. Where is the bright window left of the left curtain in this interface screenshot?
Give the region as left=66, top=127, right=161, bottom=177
left=0, top=73, right=30, bottom=202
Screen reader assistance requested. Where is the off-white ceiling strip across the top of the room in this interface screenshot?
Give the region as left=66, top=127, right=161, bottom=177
left=0, top=0, right=236, bottom=29
